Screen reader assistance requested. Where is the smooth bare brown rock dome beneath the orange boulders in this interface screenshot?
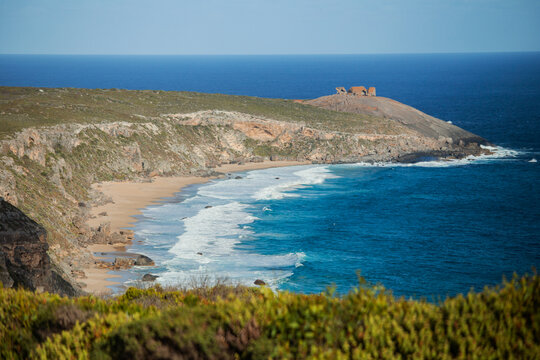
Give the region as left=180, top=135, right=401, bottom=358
left=304, top=94, right=488, bottom=145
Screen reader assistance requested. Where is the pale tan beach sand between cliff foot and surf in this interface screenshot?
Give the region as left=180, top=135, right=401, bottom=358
left=81, top=161, right=310, bottom=294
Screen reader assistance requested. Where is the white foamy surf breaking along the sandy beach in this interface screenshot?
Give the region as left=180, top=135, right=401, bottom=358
left=139, top=165, right=336, bottom=288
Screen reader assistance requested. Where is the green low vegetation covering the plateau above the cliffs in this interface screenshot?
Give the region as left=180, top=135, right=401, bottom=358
left=0, top=87, right=384, bottom=139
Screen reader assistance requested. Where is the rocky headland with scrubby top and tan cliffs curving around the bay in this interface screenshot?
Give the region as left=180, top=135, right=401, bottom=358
left=0, top=87, right=487, bottom=295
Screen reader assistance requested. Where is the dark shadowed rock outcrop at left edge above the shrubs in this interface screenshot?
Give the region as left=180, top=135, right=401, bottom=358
left=0, top=198, right=80, bottom=296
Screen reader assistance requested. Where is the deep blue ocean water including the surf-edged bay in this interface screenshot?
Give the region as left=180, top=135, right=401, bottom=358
left=0, top=53, right=540, bottom=298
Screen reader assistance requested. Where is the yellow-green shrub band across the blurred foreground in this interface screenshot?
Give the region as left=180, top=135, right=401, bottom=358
left=0, top=274, right=540, bottom=359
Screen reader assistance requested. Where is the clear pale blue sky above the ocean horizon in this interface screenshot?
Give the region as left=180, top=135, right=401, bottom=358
left=0, top=0, right=540, bottom=54
